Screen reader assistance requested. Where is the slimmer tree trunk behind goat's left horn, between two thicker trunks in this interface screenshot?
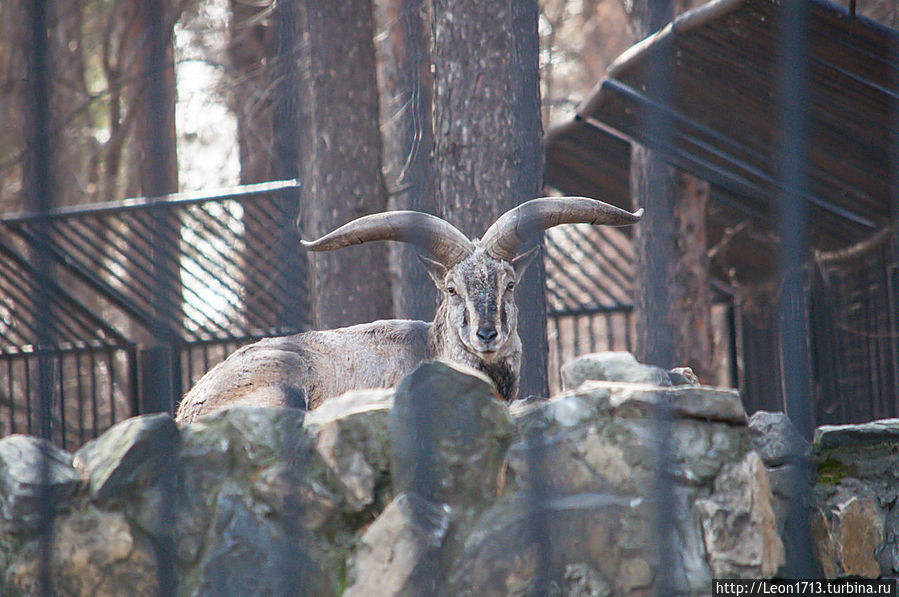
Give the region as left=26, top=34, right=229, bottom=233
left=377, top=0, right=438, bottom=321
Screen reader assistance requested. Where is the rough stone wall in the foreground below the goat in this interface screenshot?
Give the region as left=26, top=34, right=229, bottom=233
left=0, top=353, right=899, bottom=597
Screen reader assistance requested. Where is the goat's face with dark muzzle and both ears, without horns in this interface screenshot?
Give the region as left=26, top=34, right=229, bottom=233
left=428, top=249, right=531, bottom=363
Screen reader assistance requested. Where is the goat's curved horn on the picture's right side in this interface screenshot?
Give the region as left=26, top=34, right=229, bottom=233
left=481, top=197, right=643, bottom=260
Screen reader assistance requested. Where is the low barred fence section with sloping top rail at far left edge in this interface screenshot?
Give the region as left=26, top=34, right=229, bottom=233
left=0, top=238, right=137, bottom=448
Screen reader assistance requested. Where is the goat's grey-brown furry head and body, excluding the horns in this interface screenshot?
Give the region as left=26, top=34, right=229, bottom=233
left=176, top=244, right=527, bottom=423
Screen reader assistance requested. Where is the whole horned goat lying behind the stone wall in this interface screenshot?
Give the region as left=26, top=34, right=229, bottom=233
left=177, top=197, right=642, bottom=422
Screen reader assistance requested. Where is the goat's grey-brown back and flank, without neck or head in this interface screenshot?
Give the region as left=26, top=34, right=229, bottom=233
left=176, top=320, right=433, bottom=423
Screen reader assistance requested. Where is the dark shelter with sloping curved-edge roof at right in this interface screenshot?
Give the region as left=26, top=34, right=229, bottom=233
left=546, top=0, right=899, bottom=423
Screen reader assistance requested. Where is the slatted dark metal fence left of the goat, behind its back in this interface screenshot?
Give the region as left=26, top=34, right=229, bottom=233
left=0, top=181, right=308, bottom=440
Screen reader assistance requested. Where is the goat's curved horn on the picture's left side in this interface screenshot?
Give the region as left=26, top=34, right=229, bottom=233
left=300, top=211, right=474, bottom=267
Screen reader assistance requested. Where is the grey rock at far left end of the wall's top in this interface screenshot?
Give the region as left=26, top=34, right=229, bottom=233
left=0, top=435, right=81, bottom=532
